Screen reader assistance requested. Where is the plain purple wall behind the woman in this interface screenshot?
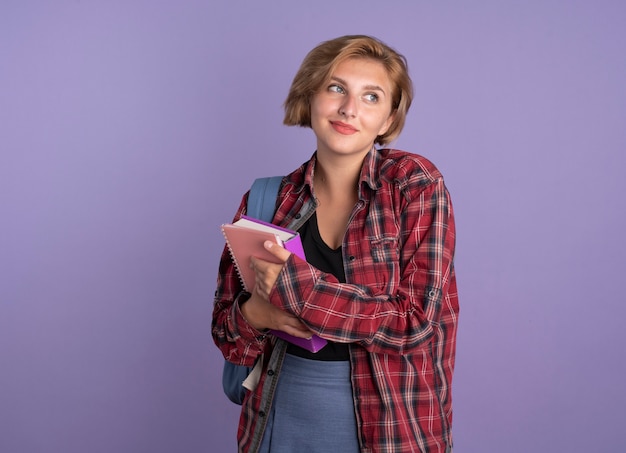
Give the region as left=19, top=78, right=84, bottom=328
left=0, top=0, right=626, bottom=453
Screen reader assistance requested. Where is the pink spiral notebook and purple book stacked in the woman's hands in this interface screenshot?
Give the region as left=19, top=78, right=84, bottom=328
left=221, top=216, right=326, bottom=352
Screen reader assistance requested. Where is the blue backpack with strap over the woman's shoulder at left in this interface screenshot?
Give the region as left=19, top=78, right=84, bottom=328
left=222, top=176, right=283, bottom=405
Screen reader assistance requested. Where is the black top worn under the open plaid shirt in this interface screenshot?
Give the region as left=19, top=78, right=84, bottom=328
left=287, top=213, right=350, bottom=361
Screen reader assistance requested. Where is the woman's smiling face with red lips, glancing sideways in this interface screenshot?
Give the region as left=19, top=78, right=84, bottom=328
left=311, top=58, right=393, bottom=158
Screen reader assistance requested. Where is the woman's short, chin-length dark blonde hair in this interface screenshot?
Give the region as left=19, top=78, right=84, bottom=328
left=283, top=35, right=413, bottom=145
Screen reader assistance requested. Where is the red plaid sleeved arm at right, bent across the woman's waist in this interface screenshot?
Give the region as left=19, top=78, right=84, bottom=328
left=270, top=178, right=455, bottom=354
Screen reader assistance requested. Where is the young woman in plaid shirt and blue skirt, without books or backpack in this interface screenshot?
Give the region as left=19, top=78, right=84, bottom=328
left=212, top=36, right=459, bottom=453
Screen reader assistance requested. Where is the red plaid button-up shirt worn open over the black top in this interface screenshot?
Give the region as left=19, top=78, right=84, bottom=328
left=212, top=149, right=459, bottom=453
